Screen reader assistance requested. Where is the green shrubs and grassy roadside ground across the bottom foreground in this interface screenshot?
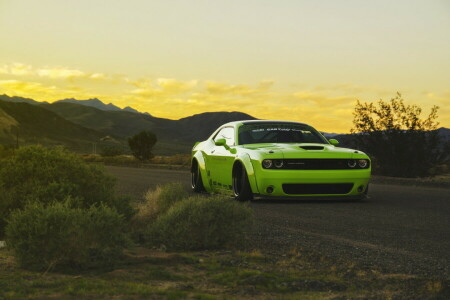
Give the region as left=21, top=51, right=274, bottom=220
left=0, top=146, right=450, bottom=299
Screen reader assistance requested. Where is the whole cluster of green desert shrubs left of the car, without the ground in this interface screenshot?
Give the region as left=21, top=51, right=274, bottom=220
left=0, top=146, right=253, bottom=271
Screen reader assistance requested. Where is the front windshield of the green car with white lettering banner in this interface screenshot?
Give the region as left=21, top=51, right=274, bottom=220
left=238, top=123, right=328, bottom=145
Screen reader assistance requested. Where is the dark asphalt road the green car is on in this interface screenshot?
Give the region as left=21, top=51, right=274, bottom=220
left=107, top=167, right=450, bottom=278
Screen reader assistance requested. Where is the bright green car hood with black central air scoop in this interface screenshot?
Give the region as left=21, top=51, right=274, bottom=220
left=241, top=143, right=365, bottom=158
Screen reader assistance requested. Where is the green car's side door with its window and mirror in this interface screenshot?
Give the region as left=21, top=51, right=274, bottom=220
left=208, top=127, right=236, bottom=191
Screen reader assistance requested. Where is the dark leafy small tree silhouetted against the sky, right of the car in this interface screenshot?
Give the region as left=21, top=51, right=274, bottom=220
left=351, top=93, right=444, bottom=177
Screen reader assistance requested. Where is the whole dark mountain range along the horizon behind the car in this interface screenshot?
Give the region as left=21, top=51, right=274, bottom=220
left=0, top=95, right=450, bottom=155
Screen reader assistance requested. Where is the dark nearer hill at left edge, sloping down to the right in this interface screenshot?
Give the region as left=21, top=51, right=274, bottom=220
left=0, top=101, right=114, bottom=151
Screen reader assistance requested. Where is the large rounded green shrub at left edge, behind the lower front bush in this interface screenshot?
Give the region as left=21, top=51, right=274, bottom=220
left=0, top=146, right=134, bottom=236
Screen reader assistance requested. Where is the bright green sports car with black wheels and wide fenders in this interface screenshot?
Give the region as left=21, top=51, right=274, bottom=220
left=191, top=120, right=371, bottom=201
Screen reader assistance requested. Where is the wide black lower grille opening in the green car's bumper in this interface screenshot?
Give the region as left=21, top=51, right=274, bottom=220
left=283, top=183, right=353, bottom=195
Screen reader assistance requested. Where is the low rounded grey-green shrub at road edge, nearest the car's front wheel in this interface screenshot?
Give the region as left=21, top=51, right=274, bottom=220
left=146, top=196, right=253, bottom=250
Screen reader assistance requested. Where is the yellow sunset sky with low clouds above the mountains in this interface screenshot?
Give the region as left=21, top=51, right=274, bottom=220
left=0, top=0, right=450, bottom=133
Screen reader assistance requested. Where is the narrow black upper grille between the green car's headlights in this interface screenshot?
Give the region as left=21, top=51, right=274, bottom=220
left=284, top=159, right=349, bottom=170
